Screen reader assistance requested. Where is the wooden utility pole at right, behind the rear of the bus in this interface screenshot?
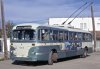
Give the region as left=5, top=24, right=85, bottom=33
left=91, top=1, right=96, bottom=52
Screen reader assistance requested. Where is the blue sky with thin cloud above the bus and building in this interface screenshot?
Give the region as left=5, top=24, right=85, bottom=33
left=0, top=0, right=100, bottom=23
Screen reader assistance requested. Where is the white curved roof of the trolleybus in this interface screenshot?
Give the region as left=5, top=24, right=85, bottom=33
left=13, top=23, right=90, bottom=33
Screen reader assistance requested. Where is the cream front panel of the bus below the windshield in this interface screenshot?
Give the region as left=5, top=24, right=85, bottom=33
left=10, top=42, right=32, bottom=57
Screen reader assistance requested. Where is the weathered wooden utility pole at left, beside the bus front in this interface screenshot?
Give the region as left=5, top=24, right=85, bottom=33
left=0, top=0, right=8, bottom=60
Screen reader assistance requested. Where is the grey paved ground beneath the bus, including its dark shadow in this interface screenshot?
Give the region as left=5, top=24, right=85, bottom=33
left=0, top=52, right=100, bottom=69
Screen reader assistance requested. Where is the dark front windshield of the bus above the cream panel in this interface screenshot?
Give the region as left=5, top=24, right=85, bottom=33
left=12, top=29, right=35, bottom=40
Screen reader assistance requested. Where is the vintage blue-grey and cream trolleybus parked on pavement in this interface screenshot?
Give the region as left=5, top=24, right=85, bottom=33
left=11, top=23, right=93, bottom=65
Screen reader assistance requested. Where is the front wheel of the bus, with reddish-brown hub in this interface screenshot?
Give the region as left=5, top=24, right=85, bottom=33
left=48, top=51, right=58, bottom=65
